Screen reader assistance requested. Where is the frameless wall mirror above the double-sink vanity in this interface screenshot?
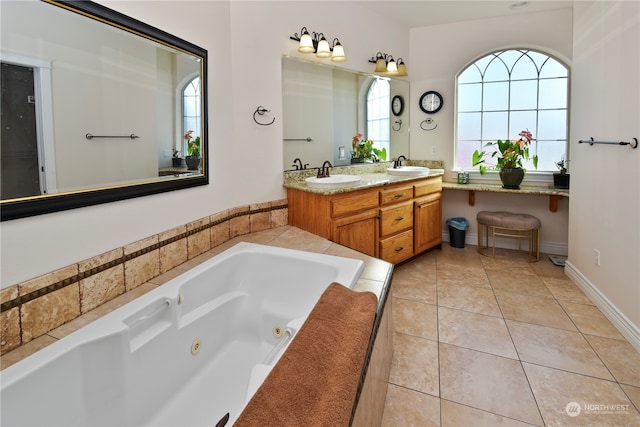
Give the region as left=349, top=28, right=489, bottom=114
left=282, top=56, right=409, bottom=171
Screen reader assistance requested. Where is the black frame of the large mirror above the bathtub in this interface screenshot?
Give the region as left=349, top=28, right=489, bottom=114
left=0, top=0, right=209, bottom=221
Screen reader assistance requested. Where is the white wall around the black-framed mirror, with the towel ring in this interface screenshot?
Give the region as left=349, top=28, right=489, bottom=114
left=0, top=0, right=410, bottom=287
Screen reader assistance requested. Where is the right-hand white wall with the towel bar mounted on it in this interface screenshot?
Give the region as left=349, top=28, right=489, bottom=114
left=569, top=1, right=640, bottom=332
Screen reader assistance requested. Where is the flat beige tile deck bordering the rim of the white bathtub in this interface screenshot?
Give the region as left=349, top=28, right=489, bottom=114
left=0, top=226, right=393, bottom=427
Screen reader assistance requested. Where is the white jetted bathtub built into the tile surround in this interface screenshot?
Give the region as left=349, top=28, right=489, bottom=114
left=0, top=243, right=363, bottom=426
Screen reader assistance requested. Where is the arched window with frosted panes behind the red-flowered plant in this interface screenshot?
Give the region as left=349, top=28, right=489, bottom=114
left=455, top=49, right=569, bottom=171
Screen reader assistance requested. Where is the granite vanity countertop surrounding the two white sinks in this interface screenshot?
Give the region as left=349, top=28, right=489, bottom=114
left=283, top=160, right=444, bottom=195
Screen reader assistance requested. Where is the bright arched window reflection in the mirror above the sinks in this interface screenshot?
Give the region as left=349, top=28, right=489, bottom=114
left=367, top=79, right=391, bottom=153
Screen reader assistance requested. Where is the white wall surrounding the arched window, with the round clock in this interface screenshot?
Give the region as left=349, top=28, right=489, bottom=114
left=409, top=8, right=573, bottom=255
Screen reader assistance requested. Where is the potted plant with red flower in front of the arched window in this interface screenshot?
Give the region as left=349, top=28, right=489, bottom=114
left=471, top=130, right=538, bottom=190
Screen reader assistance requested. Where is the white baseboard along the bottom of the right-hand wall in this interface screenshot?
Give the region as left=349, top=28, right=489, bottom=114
left=564, top=261, right=640, bottom=352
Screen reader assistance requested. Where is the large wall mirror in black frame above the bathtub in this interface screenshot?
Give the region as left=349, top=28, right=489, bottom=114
left=0, top=0, right=209, bottom=221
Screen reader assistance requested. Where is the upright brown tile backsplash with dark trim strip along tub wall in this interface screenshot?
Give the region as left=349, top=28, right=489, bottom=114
left=0, top=199, right=288, bottom=358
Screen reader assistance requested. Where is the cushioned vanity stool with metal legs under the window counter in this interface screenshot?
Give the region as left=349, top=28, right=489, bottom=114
left=476, top=211, right=542, bottom=262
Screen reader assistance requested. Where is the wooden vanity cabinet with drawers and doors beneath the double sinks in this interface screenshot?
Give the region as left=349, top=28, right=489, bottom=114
left=287, top=176, right=442, bottom=264
